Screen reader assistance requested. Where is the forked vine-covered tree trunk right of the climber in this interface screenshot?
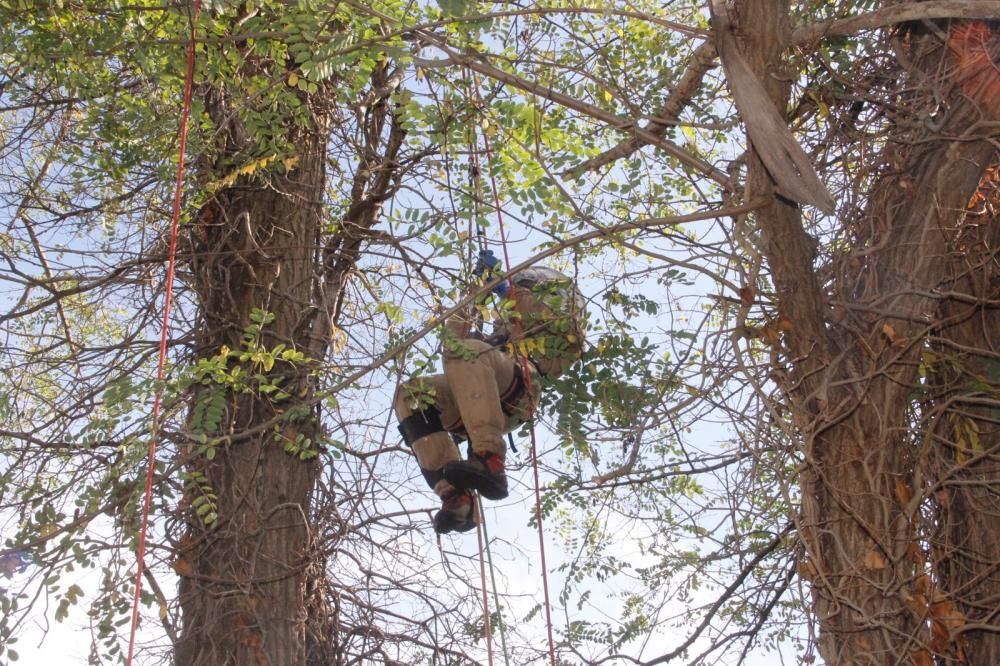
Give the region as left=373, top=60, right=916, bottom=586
left=734, top=0, right=993, bottom=666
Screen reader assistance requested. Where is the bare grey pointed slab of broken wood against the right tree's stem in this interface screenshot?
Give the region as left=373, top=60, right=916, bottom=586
left=710, top=0, right=834, bottom=213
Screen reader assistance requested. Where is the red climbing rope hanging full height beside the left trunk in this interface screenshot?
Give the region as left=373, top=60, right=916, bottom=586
left=125, top=0, right=201, bottom=666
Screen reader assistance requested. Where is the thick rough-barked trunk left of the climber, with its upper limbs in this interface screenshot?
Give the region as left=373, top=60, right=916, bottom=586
left=168, top=42, right=406, bottom=666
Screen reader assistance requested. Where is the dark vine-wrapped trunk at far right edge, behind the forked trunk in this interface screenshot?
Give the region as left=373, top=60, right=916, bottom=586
left=925, top=172, right=1000, bottom=665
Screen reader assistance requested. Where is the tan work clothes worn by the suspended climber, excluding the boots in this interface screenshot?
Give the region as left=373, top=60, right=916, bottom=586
left=394, top=267, right=585, bottom=497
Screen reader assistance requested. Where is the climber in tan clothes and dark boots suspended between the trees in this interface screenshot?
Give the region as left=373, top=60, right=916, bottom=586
left=394, top=251, right=586, bottom=534
